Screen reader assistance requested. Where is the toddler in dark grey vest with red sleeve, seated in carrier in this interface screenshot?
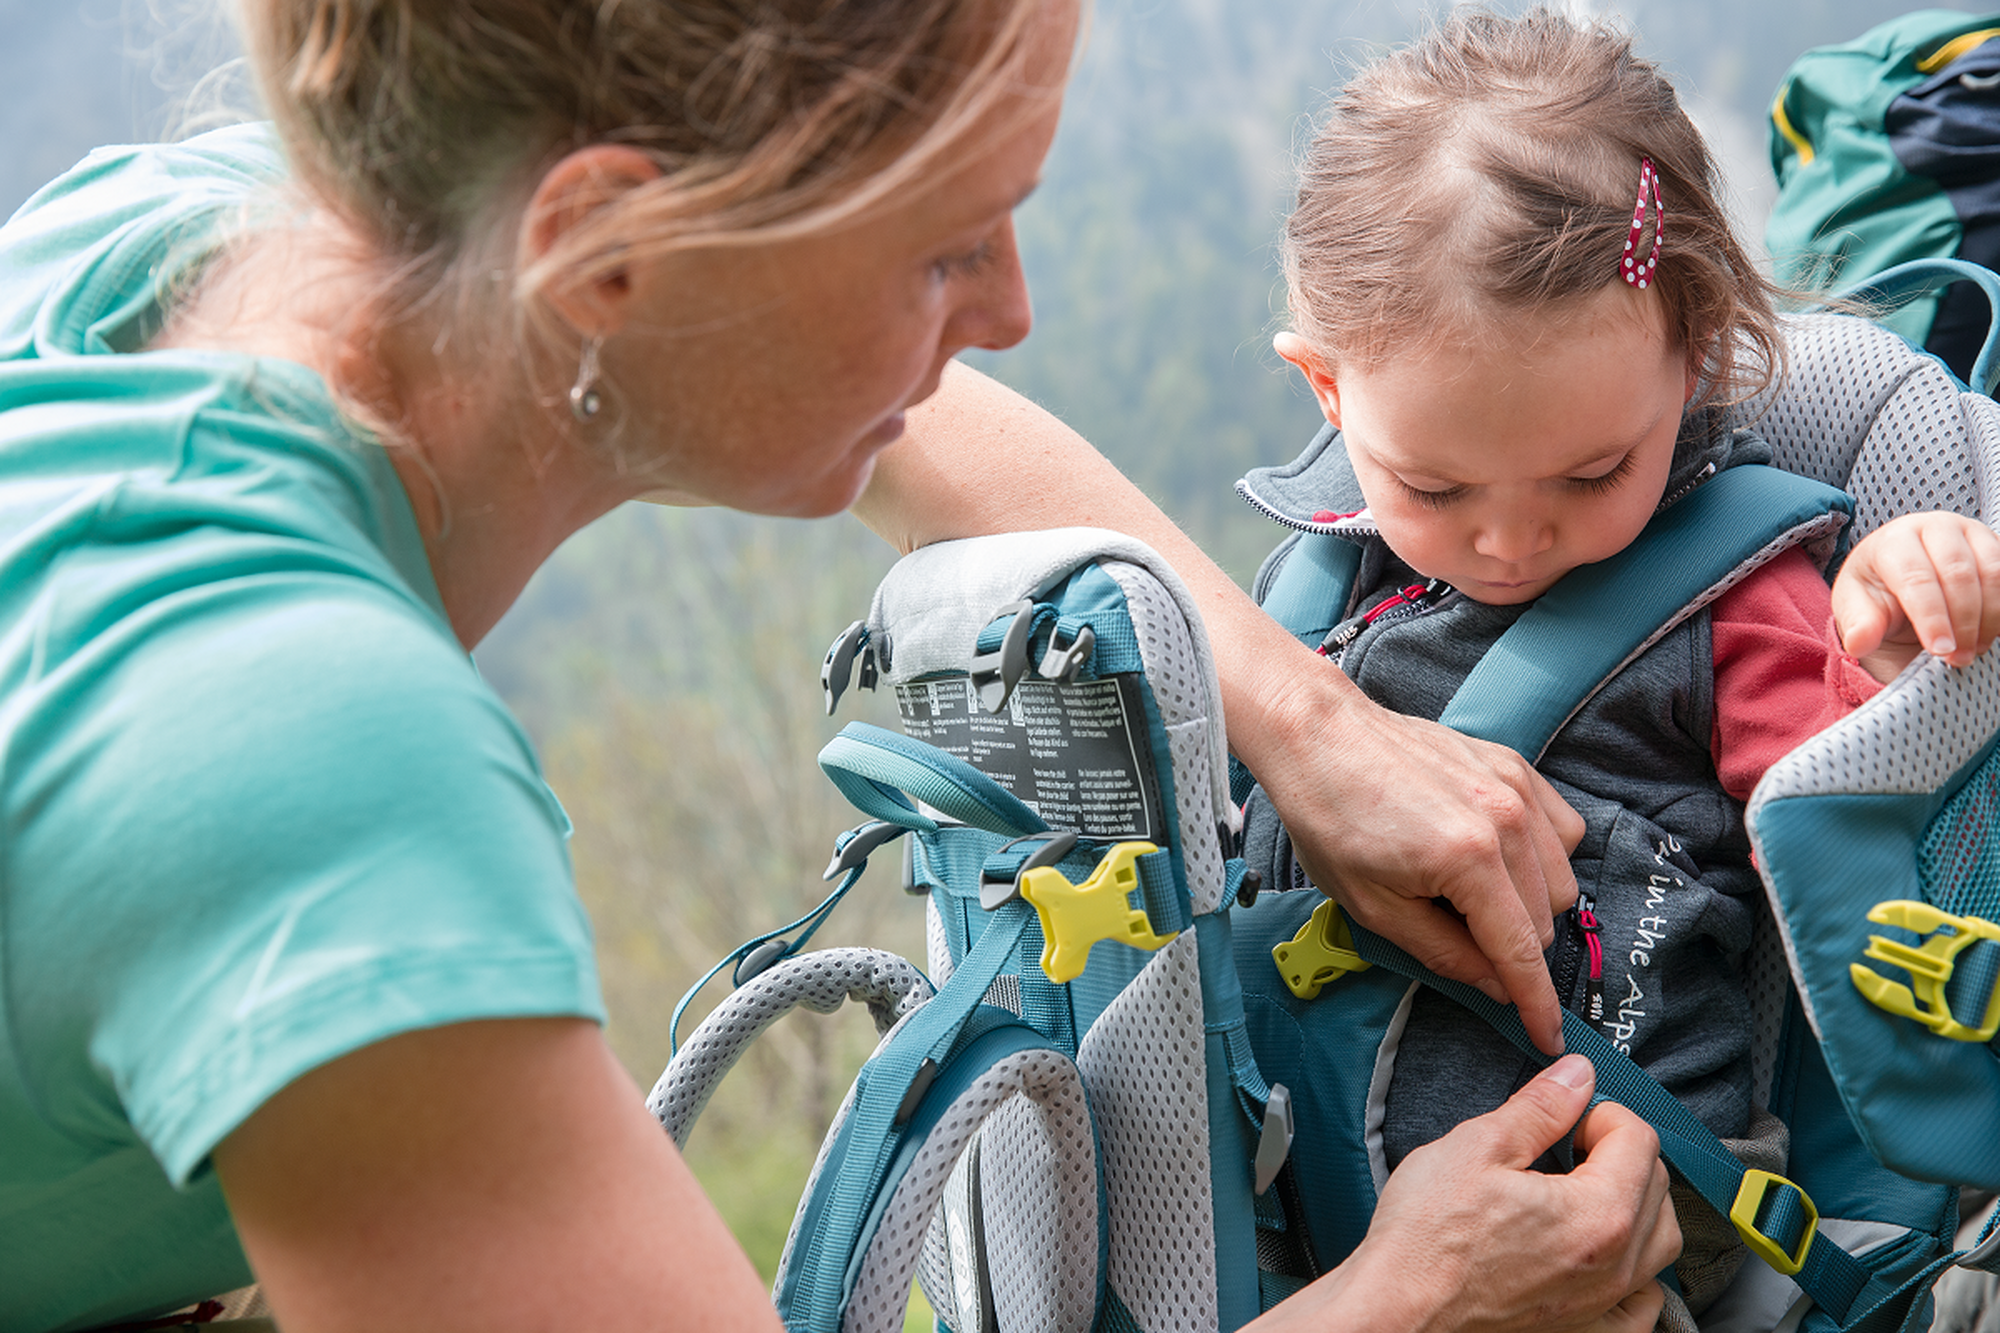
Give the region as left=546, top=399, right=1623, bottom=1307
left=1246, top=10, right=2000, bottom=1311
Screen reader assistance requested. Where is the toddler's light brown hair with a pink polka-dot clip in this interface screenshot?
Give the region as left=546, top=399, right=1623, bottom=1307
left=1284, top=10, right=1784, bottom=402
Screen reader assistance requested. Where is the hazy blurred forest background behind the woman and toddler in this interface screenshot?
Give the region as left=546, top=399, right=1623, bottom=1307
left=0, top=0, right=1970, bottom=1296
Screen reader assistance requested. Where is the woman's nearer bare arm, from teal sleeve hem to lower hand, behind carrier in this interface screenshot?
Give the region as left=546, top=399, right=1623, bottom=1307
left=214, top=1019, right=1680, bottom=1333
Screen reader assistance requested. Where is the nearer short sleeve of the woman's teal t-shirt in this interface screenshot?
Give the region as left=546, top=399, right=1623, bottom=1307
left=4, top=570, right=602, bottom=1183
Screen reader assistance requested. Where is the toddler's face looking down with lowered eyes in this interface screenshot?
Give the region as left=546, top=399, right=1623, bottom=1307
left=1288, top=282, right=1696, bottom=604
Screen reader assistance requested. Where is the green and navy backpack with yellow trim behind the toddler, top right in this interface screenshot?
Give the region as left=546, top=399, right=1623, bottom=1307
left=1764, top=10, right=2000, bottom=390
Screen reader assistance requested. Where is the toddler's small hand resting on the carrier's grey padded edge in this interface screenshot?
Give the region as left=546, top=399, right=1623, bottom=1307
left=1834, top=512, right=2000, bottom=685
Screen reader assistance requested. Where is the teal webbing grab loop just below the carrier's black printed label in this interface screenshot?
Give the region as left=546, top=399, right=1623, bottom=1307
left=820, top=723, right=1048, bottom=837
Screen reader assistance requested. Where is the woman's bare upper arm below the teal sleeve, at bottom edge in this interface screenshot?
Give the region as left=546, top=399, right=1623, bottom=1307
left=214, top=1019, right=780, bottom=1333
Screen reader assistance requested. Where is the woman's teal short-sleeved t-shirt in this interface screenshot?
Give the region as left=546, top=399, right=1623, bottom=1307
left=0, top=126, right=602, bottom=1333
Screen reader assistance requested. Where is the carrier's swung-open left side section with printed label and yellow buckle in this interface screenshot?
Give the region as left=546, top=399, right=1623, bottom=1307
left=654, top=528, right=1286, bottom=1333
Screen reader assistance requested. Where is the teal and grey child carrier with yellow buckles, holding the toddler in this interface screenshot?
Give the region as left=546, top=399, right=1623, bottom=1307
left=650, top=272, right=2000, bottom=1333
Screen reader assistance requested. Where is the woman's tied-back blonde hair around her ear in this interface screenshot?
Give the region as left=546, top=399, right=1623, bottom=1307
left=238, top=0, right=1058, bottom=392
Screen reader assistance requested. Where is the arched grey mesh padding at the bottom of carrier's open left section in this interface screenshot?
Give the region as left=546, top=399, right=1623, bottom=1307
left=842, top=1049, right=1098, bottom=1333
